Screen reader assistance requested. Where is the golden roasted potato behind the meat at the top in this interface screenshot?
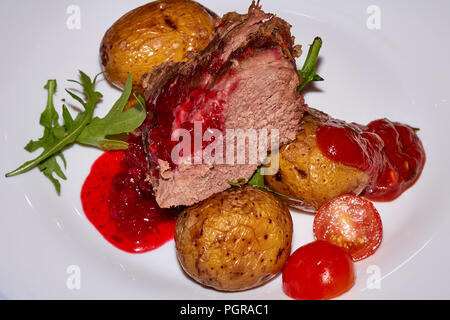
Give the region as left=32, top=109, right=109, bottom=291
left=100, top=0, right=217, bottom=93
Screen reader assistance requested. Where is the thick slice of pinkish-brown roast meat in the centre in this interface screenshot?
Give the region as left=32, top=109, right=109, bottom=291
left=142, top=3, right=306, bottom=208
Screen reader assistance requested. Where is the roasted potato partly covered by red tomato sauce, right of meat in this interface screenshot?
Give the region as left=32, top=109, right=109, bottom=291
left=265, top=109, right=369, bottom=209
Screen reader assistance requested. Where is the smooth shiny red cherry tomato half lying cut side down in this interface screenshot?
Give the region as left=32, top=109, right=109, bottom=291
left=283, top=241, right=355, bottom=300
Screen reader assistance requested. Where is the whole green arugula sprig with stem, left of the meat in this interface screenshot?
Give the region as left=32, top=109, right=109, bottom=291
left=6, top=71, right=146, bottom=194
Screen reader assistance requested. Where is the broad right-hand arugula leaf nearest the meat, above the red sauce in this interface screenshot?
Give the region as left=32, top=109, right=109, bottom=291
left=77, top=75, right=146, bottom=150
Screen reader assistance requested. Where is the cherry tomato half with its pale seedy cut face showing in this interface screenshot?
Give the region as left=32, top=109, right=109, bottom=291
left=314, top=195, right=383, bottom=261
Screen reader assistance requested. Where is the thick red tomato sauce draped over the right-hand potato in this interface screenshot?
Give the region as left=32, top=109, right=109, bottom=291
left=316, top=119, right=426, bottom=201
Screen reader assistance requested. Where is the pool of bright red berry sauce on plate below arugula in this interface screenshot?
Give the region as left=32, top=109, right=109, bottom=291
left=81, top=139, right=178, bottom=253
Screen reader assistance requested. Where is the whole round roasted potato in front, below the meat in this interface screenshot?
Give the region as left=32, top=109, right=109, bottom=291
left=175, top=186, right=292, bottom=291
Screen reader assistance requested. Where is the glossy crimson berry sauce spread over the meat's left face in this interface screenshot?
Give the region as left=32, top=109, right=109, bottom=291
left=142, top=49, right=224, bottom=173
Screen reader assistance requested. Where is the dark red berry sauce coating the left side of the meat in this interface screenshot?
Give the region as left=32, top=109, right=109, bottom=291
left=142, top=49, right=248, bottom=175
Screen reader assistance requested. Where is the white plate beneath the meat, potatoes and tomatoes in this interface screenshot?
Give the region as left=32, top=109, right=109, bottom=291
left=0, top=0, right=450, bottom=299
